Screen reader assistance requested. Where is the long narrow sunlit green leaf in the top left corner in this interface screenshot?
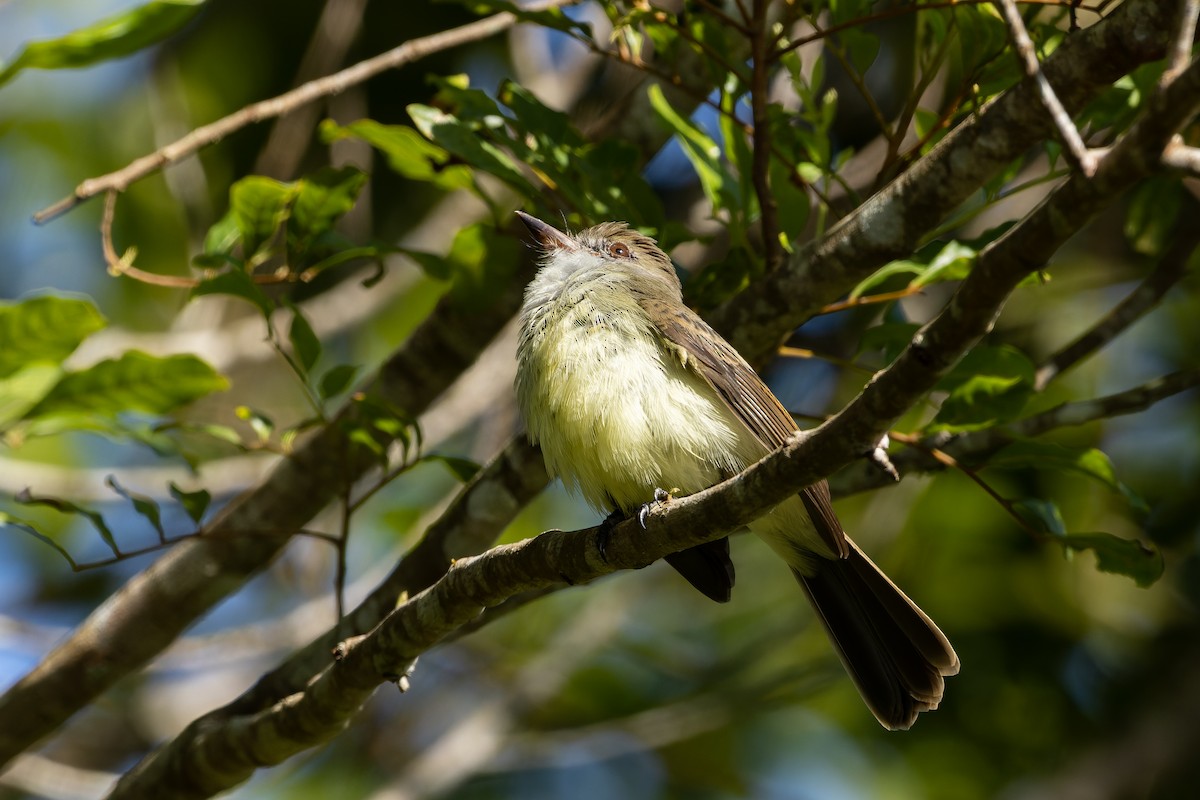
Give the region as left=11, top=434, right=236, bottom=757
left=0, top=0, right=205, bottom=86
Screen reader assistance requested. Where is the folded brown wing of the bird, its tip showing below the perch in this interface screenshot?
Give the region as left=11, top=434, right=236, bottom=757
left=640, top=297, right=850, bottom=558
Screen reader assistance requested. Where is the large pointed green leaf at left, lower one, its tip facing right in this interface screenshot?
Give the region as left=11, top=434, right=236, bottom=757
left=26, top=350, right=229, bottom=419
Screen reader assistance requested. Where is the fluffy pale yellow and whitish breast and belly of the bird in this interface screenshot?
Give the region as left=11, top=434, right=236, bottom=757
left=517, top=270, right=764, bottom=511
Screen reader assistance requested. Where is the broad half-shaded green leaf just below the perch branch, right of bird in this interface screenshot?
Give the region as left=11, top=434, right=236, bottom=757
left=928, top=345, right=1036, bottom=432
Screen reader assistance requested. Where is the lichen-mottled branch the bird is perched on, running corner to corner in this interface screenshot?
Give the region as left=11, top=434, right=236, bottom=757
left=112, top=53, right=1200, bottom=798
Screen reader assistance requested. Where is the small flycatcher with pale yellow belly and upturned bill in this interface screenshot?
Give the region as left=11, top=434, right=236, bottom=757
left=516, top=211, right=959, bottom=729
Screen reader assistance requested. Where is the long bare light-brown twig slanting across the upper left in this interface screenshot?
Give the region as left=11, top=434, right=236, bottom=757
left=34, top=0, right=580, bottom=224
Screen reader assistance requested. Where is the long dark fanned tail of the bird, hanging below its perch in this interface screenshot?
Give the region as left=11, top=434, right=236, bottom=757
left=792, top=540, right=959, bottom=730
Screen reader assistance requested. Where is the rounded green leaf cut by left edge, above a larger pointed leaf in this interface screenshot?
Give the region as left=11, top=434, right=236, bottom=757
left=0, top=295, right=108, bottom=378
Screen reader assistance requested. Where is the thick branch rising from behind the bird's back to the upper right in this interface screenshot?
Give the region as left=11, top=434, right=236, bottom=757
left=709, top=0, right=1176, bottom=362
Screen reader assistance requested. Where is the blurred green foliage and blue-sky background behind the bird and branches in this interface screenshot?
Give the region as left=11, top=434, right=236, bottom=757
left=0, top=0, right=1200, bottom=800
